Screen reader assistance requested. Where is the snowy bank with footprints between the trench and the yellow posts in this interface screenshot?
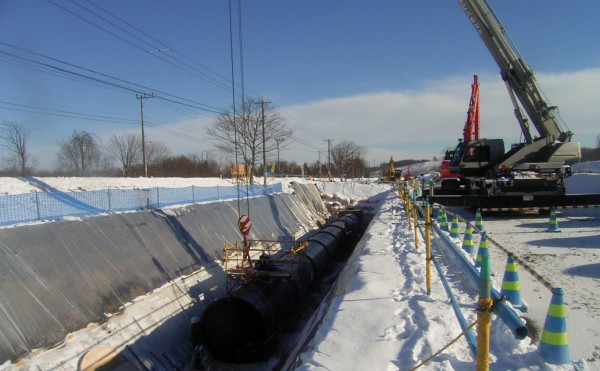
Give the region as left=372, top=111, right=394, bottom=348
left=298, top=189, right=561, bottom=370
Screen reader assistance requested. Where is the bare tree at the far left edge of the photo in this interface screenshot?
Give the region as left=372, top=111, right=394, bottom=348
left=0, top=122, right=31, bottom=176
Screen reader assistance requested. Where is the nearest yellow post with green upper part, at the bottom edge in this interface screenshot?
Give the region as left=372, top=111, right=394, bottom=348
left=477, top=240, right=492, bottom=371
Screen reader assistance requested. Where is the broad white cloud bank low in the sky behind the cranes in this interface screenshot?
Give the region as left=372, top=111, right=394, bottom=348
left=283, top=68, right=600, bottom=166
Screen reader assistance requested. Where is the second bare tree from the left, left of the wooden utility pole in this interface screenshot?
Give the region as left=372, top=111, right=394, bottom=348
left=58, top=130, right=101, bottom=176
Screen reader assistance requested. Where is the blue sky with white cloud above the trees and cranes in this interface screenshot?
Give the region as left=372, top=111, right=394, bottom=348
left=0, top=0, right=600, bottom=168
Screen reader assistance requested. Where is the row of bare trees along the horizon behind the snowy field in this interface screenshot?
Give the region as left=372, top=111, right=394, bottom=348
left=0, top=99, right=369, bottom=181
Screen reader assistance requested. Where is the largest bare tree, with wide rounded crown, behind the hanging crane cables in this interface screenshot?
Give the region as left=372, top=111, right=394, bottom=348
left=206, top=99, right=293, bottom=182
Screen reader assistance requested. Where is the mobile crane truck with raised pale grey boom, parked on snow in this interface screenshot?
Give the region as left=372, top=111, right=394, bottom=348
left=432, top=0, right=600, bottom=208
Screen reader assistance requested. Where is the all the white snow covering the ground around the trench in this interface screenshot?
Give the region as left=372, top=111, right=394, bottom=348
left=0, top=173, right=600, bottom=370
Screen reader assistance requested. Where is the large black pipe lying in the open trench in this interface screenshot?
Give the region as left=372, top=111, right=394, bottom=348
left=192, top=211, right=360, bottom=363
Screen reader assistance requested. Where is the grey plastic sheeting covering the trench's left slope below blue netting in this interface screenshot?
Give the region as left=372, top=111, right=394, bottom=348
left=0, top=183, right=328, bottom=364
